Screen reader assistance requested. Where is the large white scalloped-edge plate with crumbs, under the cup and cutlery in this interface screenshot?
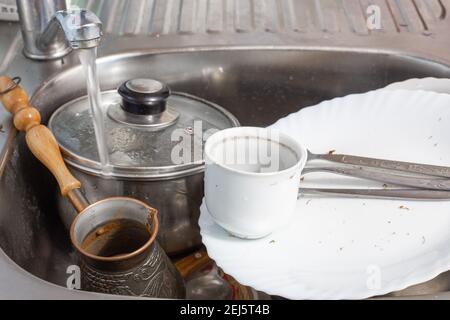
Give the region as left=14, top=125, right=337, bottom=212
left=199, top=90, right=450, bottom=299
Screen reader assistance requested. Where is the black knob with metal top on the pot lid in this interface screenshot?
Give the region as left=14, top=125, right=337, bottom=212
left=118, top=79, right=170, bottom=115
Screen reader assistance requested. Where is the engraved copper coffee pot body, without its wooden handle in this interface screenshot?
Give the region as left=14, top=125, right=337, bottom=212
left=70, top=197, right=186, bottom=299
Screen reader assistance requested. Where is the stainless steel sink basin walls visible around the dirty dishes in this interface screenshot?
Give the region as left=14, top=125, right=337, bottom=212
left=0, top=48, right=450, bottom=296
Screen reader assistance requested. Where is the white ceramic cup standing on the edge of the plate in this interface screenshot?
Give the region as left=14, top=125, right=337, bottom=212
left=205, top=127, right=307, bottom=239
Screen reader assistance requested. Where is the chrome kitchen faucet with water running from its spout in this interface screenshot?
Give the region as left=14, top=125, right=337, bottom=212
left=17, top=0, right=103, bottom=60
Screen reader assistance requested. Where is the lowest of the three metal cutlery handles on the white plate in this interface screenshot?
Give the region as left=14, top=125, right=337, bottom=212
left=299, top=188, right=450, bottom=201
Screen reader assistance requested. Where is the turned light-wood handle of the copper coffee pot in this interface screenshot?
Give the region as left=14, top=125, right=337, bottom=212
left=0, top=76, right=81, bottom=196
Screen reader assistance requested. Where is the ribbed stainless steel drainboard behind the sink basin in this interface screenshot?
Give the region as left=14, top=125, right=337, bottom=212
left=72, top=0, right=449, bottom=37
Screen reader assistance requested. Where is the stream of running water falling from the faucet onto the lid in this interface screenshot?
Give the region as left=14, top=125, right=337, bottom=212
left=78, top=48, right=111, bottom=175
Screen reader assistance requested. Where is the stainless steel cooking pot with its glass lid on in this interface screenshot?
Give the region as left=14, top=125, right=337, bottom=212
left=48, top=79, right=239, bottom=255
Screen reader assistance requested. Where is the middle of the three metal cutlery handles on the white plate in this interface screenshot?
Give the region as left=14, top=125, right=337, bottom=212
left=302, top=165, right=450, bottom=191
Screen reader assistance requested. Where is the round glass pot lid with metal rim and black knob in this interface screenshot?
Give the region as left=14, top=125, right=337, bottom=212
left=49, top=79, right=239, bottom=179
